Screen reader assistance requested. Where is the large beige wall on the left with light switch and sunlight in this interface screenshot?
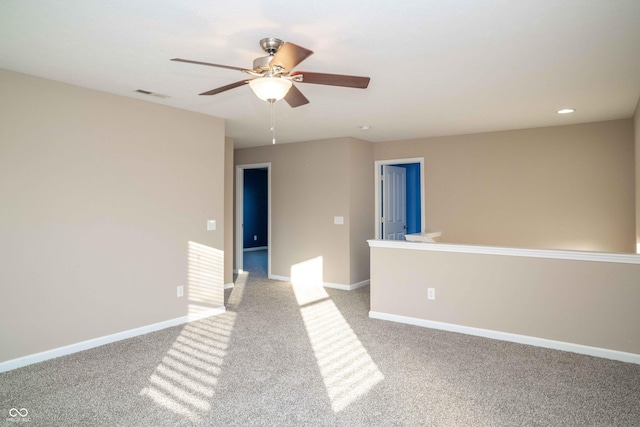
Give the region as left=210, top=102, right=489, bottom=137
left=0, top=70, right=225, bottom=361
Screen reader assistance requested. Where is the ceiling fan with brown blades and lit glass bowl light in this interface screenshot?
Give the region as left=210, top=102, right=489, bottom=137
left=171, top=37, right=370, bottom=108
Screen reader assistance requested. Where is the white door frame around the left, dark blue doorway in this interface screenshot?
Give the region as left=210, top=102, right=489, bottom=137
left=234, top=162, right=272, bottom=277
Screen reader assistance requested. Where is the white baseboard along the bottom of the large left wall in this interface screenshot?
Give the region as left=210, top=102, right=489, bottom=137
left=0, top=306, right=226, bottom=372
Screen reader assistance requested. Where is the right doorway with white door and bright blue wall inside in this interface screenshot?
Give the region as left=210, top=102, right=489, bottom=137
left=375, top=157, right=425, bottom=240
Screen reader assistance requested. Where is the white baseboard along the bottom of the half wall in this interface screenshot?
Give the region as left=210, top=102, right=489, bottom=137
left=369, top=311, right=640, bottom=364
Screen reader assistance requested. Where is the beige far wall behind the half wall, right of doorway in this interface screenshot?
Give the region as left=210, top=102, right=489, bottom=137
left=374, top=119, right=636, bottom=252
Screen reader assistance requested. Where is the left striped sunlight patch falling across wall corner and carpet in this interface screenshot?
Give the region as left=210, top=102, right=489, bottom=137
left=140, top=242, right=240, bottom=423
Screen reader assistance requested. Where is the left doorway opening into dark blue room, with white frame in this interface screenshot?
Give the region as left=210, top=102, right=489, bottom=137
left=235, top=163, right=271, bottom=277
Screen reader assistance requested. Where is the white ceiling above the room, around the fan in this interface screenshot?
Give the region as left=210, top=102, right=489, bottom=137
left=0, top=0, right=640, bottom=147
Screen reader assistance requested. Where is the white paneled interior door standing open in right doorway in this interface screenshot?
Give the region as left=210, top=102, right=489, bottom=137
left=382, top=165, right=407, bottom=240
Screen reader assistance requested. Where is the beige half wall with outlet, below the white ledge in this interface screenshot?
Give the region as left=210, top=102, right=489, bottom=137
left=371, top=243, right=640, bottom=354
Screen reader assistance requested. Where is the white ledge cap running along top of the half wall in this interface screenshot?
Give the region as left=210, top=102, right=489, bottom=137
left=367, top=240, right=640, bottom=264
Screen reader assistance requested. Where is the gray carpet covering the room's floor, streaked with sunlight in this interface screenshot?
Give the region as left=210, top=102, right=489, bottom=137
left=0, top=249, right=640, bottom=426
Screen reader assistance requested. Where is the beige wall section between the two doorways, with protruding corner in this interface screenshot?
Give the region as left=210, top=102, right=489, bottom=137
left=234, top=138, right=373, bottom=285
